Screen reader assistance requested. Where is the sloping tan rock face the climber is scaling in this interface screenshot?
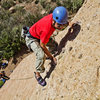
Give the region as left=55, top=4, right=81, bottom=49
left=0, top=0, right=100, bottom=100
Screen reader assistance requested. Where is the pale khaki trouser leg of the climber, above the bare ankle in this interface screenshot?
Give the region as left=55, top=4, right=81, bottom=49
left=25, top=36, right=45, bottom=73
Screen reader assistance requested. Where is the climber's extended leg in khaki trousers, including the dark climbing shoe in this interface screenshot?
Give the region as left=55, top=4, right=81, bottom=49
left=26, top=37, right=46, bottom=86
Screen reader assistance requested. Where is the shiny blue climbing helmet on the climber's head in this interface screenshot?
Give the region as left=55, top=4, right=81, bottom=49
left=53, top=6, right=68, bottom=24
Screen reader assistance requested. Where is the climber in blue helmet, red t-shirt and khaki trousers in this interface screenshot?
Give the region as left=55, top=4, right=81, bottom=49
left=23, top=6, right=74, bottom=86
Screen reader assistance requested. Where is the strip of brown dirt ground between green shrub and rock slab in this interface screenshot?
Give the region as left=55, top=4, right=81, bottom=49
left=0, top=45, right=32, bottom=76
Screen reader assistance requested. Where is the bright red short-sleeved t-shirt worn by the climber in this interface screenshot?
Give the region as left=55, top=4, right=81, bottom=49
left=29, top=14, right=55, bottom=44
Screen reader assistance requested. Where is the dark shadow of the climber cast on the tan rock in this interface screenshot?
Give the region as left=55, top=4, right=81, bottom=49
left=44, top=24, right=81, bottom=79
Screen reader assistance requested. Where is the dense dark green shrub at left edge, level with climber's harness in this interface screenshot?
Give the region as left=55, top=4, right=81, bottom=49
left=0, top=27, right=21, bottom=60
